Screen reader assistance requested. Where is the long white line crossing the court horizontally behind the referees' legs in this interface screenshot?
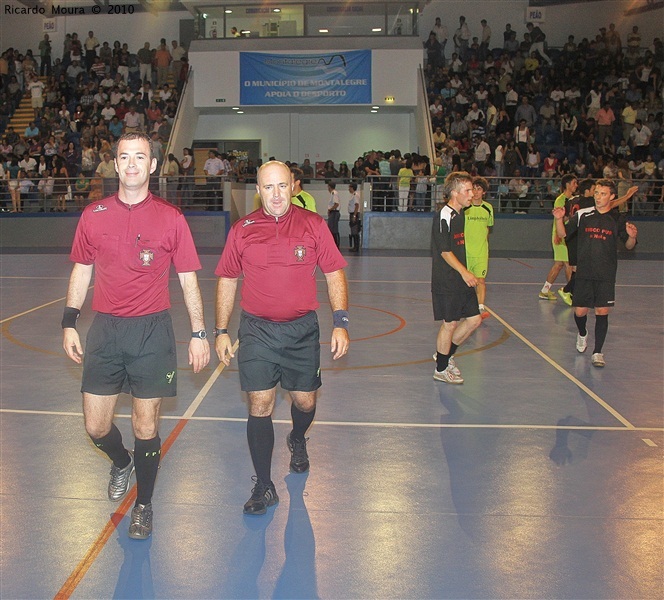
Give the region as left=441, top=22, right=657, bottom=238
left=0, top=408, right=664, bottom=432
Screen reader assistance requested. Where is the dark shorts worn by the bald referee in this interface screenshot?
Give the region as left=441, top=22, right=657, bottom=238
left=237, top=311, right=321, bottom=392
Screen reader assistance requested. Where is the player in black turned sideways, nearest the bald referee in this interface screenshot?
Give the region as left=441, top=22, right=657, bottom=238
left=431, top=171, right=482, bottom=384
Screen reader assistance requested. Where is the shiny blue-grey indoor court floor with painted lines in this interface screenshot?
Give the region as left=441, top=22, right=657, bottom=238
left=0, top=253, right=664, bottom=600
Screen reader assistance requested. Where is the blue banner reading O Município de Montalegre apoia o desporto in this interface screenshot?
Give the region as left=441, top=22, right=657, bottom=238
left=240, top=50, right=371, bottom=105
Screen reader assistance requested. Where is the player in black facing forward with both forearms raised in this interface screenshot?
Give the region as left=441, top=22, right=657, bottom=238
left=553, top=179, right=638, bottom=367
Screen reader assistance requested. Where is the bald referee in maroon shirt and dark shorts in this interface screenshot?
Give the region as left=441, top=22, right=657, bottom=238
left=214, top=160, right=349, bottom=515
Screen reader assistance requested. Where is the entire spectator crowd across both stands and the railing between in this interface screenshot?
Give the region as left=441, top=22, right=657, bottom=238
left=0, top=16, right=664, bottom=213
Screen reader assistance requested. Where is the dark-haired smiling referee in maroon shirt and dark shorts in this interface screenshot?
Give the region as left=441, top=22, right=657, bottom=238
left=62, top=133, right=210, bottom=539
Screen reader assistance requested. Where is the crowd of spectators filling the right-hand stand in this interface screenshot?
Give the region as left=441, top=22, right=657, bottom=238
left=424, top=16, right=664, bottom=212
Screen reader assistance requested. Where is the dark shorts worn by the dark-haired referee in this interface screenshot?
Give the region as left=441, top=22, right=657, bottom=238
left=81, top=311, right=177, bottom=399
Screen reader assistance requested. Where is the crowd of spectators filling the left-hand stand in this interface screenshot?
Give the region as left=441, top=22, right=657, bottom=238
left=0, top=31, right=188, bottom=212
